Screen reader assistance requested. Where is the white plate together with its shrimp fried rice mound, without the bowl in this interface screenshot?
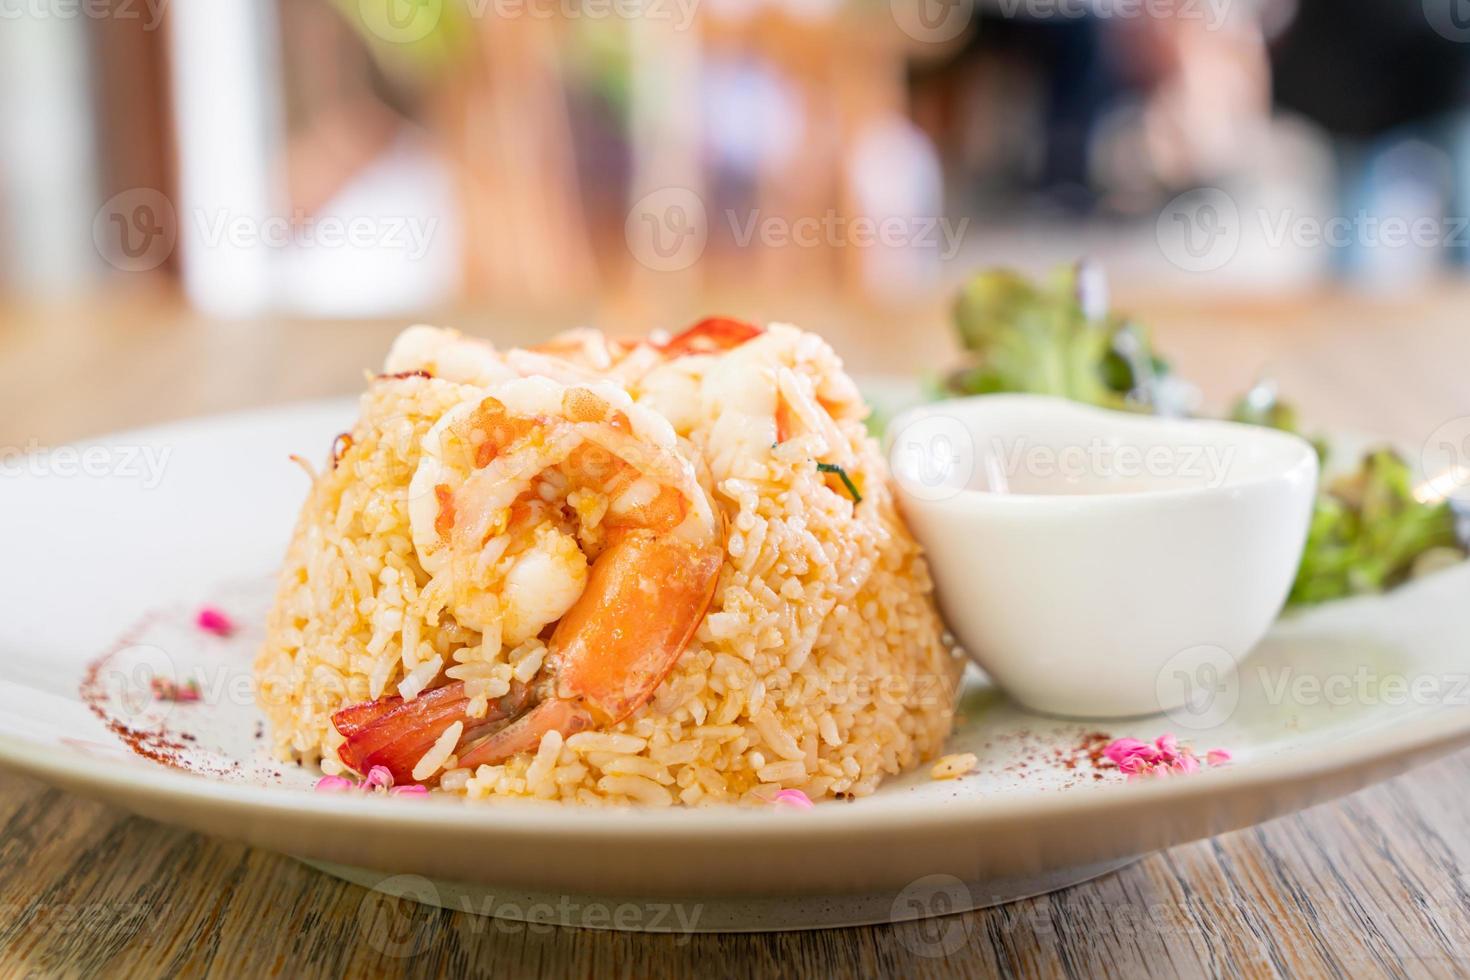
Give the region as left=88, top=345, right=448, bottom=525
left=0, top=319, right=1470, bottom=929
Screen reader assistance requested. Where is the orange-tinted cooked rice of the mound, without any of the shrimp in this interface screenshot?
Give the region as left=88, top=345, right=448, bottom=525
left=256, top=335, right=960, bottom=805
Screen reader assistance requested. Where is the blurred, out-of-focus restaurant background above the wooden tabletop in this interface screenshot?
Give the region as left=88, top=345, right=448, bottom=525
left=0, top=0, right=1470, bottom=329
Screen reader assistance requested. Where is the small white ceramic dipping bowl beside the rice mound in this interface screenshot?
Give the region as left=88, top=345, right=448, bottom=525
left=888, top=395, right=1317, bottom=718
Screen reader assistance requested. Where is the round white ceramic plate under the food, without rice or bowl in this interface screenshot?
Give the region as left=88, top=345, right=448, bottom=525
left=0, top=401, right=1470, bottom=929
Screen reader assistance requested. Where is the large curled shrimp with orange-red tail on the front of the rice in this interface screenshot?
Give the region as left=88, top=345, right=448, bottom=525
left=334, top=378, right=725, bottom=782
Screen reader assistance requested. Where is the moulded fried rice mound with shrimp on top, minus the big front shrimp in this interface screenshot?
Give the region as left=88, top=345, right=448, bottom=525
left=254, top=325, right=961, bottom=805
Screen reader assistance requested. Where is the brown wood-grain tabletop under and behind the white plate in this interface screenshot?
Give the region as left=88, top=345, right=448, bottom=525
left=0, top=287, right=1470, bottom=977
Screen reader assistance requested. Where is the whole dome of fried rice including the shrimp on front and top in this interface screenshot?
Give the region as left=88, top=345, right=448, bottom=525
left=256, top=319, right=961, bottom=805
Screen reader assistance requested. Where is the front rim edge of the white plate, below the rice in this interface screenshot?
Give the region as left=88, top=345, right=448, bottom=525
left=0, top=690, right=1470, bottom=842
